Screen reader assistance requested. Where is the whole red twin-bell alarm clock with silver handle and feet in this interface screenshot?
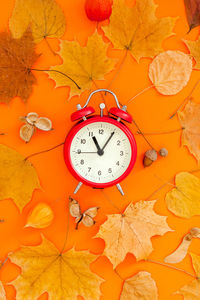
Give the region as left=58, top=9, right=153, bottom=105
left=64, top=89, right=137, bottom=195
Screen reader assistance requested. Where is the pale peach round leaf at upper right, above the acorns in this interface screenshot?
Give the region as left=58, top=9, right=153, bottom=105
left=149, top=50, right=192, bottom=95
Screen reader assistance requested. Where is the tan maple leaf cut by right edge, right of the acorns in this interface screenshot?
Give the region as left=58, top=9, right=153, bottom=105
left=178, top=101, right=200, bottom=161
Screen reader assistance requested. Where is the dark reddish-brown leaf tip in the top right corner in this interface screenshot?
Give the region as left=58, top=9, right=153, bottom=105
left=184, top=0, right=200, bottom=31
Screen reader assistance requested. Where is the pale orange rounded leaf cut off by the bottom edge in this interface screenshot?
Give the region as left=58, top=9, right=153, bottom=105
left=120, top=271, right=158, bottom=300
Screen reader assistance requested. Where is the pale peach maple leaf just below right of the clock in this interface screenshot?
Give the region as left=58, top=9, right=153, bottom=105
left=96, top=201, right=171, bottom=268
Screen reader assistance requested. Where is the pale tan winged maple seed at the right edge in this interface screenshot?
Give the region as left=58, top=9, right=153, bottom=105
left=164, top=227, right=200, bottom=264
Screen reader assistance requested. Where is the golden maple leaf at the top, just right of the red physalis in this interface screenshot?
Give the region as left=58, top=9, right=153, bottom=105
left=103, top=0, right=175, bottom=61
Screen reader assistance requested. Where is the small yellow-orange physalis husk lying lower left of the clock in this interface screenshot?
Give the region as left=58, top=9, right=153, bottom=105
left=25, top=203, right=54, bottom=228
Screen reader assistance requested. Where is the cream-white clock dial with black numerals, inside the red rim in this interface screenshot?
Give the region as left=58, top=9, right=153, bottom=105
left=70, top=122, right=132, bottom=183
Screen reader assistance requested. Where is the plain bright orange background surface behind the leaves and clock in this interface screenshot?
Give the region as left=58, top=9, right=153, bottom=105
left=0, top=0, right=200, bottom=300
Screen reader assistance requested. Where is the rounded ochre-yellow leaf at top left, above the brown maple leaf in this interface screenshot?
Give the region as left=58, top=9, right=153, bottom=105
left=9, top=0, right=65, bottom=42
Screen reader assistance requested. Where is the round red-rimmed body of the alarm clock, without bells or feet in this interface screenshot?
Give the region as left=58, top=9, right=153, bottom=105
left=66, top=117, right=136, bottom=187
